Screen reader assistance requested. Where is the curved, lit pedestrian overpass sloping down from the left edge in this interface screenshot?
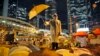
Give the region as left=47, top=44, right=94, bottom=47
left=0, top=16, right=36, bottom=33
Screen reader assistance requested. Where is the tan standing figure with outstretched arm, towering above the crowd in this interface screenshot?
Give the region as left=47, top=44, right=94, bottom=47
left=45, top=13, right=62, bottom=49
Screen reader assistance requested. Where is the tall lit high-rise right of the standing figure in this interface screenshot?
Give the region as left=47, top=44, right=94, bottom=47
left=67, top=0, right=91, bottom=32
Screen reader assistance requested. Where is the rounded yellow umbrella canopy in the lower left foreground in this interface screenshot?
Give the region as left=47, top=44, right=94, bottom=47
left=9, top=46, right=32, bottom=56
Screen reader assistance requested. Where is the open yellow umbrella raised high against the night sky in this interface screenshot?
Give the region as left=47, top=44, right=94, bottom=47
left=28, top=4, right=49, bottom=19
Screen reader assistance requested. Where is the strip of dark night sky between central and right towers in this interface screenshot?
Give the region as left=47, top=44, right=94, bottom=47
left=56, top=0, right=68, bottom=29
